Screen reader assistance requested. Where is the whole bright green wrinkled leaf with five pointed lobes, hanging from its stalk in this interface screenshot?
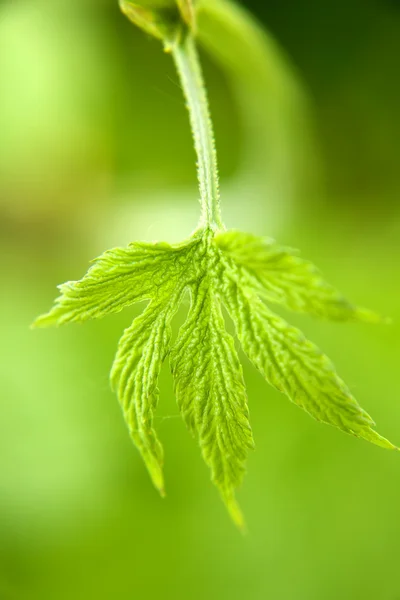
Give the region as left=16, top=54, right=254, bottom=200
left=35, top=228, right=395, bottom=527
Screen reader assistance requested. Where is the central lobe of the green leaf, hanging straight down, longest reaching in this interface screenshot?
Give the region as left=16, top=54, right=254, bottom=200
left=170, top=274, right=253, bottom=528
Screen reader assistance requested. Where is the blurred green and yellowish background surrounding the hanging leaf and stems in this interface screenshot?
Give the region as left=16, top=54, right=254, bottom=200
left=0, top=0, right=400, bottom=600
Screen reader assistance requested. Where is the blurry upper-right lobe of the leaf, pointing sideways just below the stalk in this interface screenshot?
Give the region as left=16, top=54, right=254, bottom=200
left=216, top=230, right=382, bottom=322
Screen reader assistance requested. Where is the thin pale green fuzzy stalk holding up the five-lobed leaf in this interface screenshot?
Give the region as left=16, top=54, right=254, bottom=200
left=171, top=33, right=223, bottom=229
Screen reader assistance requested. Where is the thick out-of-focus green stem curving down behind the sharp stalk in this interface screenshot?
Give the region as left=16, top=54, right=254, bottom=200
left=198, top=0, right=319, bottom=213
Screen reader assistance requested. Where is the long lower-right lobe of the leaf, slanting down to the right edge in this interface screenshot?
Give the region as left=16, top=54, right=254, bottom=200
left=216, top=248, right=395, bottom=449
